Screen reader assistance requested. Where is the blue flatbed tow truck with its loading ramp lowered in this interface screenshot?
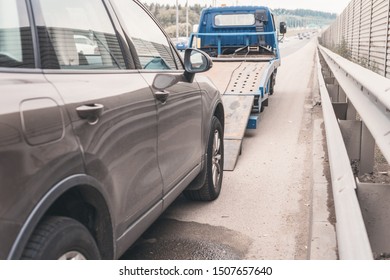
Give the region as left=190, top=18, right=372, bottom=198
left=189, top=6, right=287, bottom=171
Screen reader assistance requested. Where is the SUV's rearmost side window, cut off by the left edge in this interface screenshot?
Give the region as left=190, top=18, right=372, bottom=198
left=0, top=0, right=35, bottom=68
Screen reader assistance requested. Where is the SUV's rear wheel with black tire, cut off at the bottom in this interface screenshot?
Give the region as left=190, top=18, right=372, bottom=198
left=22, top=216, right=100, bottom=260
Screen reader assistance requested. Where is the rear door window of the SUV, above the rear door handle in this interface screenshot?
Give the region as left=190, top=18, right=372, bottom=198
left=35, top=0, right=126, bottom=70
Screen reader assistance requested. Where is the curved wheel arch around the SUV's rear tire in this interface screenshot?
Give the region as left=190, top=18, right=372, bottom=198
left=8, top=174, right=115, bottom=259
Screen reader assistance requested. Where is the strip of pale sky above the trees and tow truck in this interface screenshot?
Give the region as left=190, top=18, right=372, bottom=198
left=140, top=0, right=351, bottom=14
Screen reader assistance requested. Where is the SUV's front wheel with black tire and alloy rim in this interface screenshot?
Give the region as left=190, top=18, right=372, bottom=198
left=184, top=116, right=224, bottom=201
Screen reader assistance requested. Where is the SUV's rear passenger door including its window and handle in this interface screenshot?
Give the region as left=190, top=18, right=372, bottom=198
left=30, top=0, right=162, bottom=245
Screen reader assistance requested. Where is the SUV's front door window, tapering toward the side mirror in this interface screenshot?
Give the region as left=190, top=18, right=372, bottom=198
left=113, top=0, right=182, bottom=70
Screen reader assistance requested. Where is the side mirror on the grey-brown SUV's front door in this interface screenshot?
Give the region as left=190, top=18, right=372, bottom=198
left=184, top=48, right=213, bottom=83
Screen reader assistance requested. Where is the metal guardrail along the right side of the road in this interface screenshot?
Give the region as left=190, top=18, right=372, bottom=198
left=318, top=44, right=390, bottom=259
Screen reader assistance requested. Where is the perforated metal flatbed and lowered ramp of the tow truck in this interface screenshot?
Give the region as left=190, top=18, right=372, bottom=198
left=201, top=61, right=268, bottom=171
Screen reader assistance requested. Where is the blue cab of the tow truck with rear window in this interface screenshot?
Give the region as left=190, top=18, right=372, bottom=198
left=189, top=6, right=286, bottom=60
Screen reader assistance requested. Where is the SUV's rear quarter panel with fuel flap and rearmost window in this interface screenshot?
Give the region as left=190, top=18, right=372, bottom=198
left=0, top=0, right=84, bottom=260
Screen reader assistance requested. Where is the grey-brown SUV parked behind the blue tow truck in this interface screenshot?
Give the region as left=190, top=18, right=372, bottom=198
left=0, top=0, right=224, bottom=259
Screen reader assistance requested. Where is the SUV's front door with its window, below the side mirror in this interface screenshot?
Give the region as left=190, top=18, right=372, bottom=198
left=111, top=0, right=205, bottom=201
